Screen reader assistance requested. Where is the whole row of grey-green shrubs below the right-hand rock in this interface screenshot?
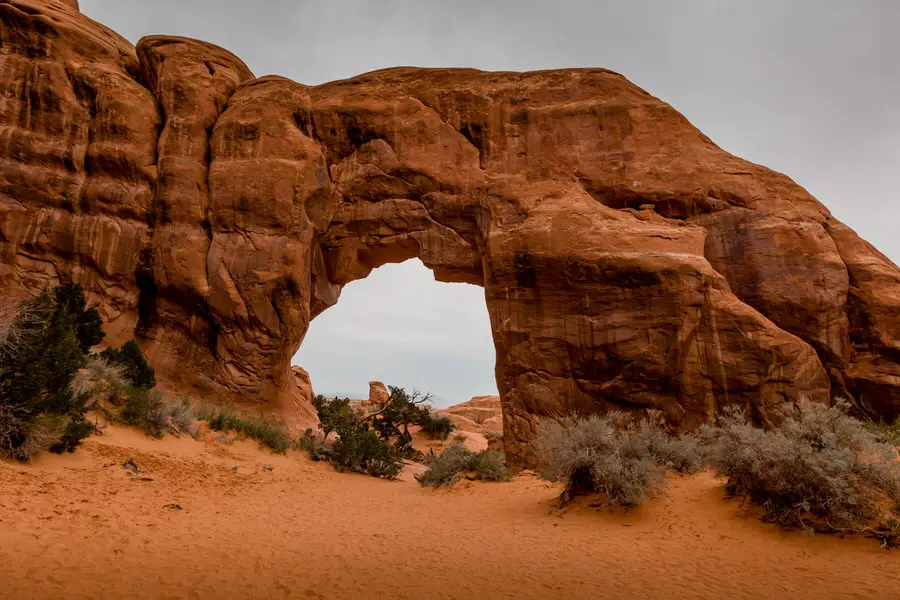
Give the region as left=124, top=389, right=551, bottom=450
left=535, top=401, right=900, bottom=543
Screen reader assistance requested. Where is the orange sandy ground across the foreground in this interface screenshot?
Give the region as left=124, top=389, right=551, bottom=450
left=0, top=428, right=900, bottom=600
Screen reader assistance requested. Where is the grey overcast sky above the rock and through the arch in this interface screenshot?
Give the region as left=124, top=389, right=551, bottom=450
left=81, top=0, right=900, bottom=403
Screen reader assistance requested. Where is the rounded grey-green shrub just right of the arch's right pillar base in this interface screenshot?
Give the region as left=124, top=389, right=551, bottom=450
left=535, top=411, right=702, bottom=508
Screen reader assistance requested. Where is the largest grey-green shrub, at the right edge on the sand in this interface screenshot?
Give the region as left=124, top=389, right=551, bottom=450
left=700, top=401, right=900, bottom=531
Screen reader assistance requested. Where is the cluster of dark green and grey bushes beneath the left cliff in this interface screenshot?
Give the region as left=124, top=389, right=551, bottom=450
left=0, top=284, right=200, bottom=461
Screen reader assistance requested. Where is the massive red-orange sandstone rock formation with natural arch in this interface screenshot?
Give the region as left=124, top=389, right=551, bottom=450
left=0, top=0, right=900, bottom=465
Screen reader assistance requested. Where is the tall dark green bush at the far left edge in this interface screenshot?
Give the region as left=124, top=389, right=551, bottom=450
left=0, top=284, right=103, bottom=458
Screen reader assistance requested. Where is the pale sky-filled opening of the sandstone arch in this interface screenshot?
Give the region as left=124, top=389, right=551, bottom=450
left=292, top=258, right=498, bottom=408
